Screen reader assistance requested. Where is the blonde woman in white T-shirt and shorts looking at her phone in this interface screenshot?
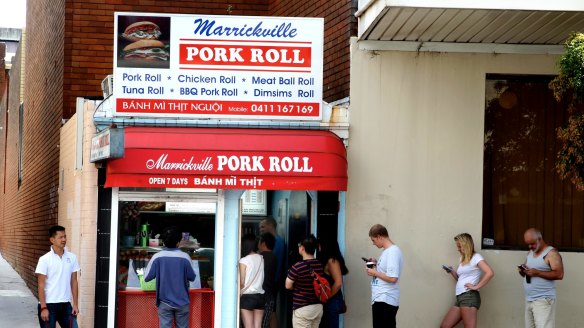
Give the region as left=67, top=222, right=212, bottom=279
left=440, top=233, right=495, bottom=328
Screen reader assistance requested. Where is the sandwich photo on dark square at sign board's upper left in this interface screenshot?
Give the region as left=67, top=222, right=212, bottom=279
left=117, top=16, right=170, bottom=68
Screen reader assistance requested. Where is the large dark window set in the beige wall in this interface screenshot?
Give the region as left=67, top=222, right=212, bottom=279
left=483, top=75, right=584, bottom=251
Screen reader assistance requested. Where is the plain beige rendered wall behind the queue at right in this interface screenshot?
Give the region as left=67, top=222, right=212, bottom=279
left=345, top=41, right=584, bottom=327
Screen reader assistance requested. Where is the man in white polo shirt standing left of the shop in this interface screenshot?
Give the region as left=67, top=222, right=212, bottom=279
left=35, top=226, right=81, bottom=328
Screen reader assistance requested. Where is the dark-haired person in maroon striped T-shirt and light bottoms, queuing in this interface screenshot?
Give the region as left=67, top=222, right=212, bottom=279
left=286, top=235, right=324, bottom=328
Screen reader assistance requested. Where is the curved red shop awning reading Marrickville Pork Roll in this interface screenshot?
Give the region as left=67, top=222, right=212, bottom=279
left=105, top=127, right=347, bottom=190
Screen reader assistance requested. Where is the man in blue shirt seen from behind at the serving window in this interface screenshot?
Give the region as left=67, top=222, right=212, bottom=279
left=144, top=227, right=196, bottom=328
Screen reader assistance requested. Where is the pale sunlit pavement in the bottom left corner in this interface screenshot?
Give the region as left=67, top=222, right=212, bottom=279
left=0, top=254, right=39, bottom=328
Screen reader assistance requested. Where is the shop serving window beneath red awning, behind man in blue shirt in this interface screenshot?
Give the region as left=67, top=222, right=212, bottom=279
left=118, top=201, right=216, bottom=289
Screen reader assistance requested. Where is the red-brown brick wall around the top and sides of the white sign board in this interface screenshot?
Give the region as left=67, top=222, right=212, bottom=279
left=63, top=0, right=357, bottom=118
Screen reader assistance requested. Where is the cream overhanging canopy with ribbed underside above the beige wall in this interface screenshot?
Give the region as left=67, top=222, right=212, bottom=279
left=356, top=0, right=584, bottom=54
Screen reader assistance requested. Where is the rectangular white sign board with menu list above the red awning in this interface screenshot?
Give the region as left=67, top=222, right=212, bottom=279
left=113, top=13, right=324, bottom=120
